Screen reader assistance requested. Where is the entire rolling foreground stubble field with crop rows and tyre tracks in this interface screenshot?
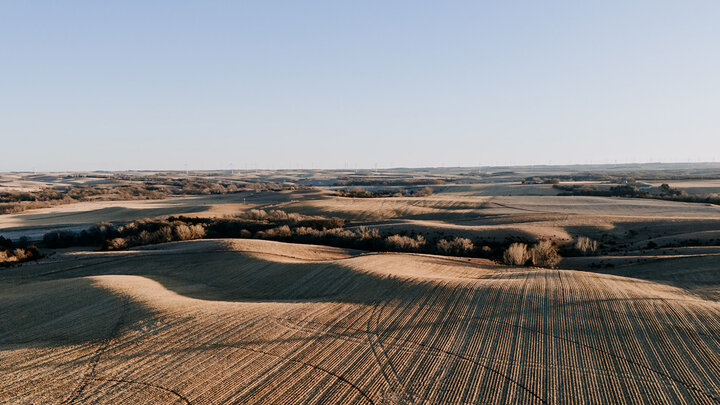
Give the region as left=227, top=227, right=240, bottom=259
left=0, top=241, right=720, bottom=404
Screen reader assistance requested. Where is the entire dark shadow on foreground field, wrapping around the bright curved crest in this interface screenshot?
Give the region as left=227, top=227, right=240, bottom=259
left=0, top=251, right=422, bottom=348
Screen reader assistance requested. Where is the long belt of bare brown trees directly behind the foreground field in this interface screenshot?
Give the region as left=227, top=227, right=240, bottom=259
left=29, top=209, right=620, bottom=268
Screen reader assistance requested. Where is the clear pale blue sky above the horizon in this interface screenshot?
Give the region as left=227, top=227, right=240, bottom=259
left=0, top=0, right=720, bottom=171
